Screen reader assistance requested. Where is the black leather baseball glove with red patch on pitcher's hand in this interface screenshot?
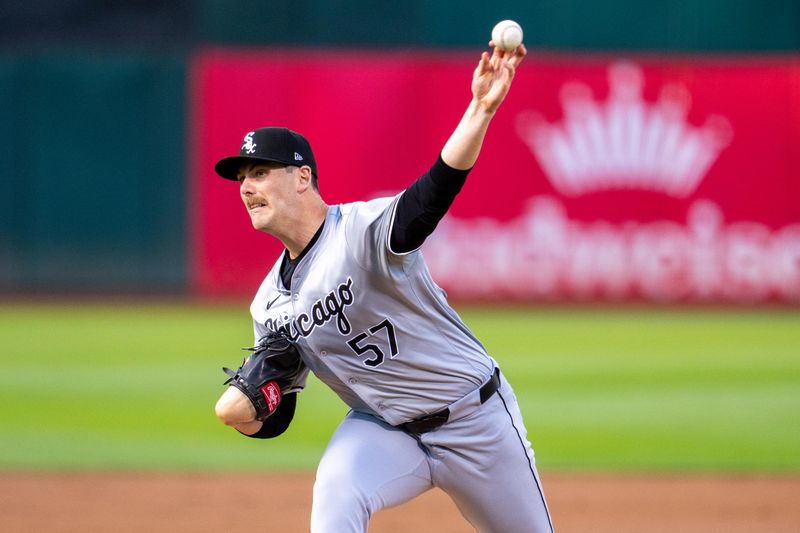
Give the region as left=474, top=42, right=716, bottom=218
left=222, top=332, right=303, bottom=420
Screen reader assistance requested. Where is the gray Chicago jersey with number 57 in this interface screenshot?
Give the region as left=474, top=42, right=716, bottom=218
left=250, top=196, right=495, bottom=425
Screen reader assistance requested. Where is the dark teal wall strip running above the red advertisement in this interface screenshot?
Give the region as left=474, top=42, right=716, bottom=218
left=197, top=0, right=800, bottom=51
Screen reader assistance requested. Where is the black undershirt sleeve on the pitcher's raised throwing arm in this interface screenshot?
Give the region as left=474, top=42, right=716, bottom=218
left=389, top=155, right=469, bottom=253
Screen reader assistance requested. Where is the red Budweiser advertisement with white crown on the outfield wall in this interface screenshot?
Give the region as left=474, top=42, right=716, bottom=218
left=189, top=50, right=800, bottom=303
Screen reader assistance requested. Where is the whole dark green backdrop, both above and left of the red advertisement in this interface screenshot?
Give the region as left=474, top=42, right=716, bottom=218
left=0, top=0, right=800, bottom=292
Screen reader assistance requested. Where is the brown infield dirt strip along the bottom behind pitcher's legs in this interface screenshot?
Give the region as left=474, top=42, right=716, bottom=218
left=0, top=472, right=800, bottom=533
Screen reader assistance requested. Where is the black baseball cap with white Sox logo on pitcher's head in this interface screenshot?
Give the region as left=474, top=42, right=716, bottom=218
left=214, top=128, right=317, bottom=180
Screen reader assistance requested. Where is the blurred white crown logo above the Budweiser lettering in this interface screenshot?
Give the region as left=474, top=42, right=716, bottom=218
left=516, top=62, right=732, bottom=198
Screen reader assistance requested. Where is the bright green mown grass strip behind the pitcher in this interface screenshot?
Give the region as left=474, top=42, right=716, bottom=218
left=0, top=302, right=800, bottom=473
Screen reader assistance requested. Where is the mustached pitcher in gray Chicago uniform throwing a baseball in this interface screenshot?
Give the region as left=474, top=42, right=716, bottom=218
left=215, top=42, right=553, bottom=533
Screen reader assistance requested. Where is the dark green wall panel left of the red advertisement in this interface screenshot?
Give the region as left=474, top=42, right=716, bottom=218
left=0, top=50, right=186, bottom=291
